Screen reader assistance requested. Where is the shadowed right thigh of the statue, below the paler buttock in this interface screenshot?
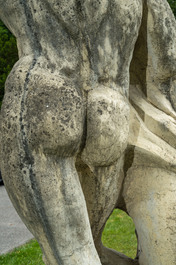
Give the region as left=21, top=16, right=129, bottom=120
left=76, top=156, right=138, bottom=265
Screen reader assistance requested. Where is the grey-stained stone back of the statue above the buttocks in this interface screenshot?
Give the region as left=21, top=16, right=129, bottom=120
left=2, top=0, right=142, bottom=87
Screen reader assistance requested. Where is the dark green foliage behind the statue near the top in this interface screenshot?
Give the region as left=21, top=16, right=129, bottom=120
left=0, top=0, right=176, bottom=106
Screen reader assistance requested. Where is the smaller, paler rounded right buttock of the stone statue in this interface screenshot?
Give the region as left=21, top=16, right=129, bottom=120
left=82, top=86, right=129, bottom=166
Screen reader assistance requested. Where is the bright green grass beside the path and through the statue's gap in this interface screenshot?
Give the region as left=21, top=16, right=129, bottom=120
left=0, top=210, right=137, bottom=265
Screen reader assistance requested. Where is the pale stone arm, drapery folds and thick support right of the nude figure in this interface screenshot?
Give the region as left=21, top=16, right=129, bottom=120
left=123, top=1, right=176, bottom=265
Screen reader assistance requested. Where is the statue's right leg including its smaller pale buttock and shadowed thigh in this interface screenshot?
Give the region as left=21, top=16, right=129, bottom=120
left=77, top=85, right=137, bottom=265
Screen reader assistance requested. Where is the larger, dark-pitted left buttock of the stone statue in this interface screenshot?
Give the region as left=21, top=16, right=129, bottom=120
left=26, top=73, right=85, bottom=156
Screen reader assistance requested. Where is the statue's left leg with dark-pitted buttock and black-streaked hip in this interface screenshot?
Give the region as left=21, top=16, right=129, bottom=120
left=1, top=59, right=101, bottom=265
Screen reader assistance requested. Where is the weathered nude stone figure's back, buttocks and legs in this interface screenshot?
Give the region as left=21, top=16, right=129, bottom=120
left=0, top=0, right=142, bottom=265
